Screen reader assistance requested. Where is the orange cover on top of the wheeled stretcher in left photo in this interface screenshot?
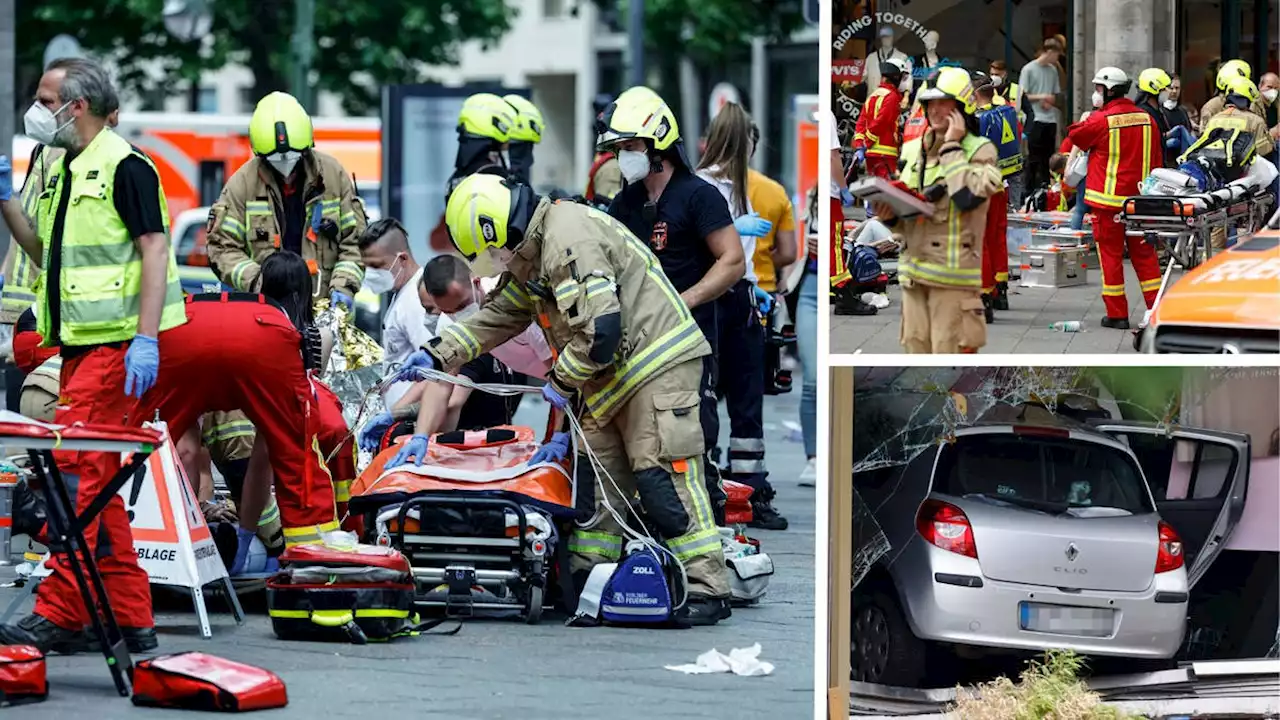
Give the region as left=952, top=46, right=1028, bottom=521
left=351, top=425, right=573, bottom=507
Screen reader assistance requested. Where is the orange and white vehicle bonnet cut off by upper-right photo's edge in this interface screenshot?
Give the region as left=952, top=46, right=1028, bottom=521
left=1152, top=231, right=1280, bottom=329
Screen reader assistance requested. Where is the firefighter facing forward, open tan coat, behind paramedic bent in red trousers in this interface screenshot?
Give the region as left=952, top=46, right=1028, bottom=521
left=206, top=92, right=366, bottom=302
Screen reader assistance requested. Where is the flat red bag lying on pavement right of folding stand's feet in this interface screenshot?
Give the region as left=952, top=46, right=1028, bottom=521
left=133, top=652, right=289, bottom=712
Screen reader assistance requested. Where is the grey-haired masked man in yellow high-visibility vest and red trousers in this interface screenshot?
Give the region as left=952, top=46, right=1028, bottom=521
left=0, top=59, right=186, bottom=652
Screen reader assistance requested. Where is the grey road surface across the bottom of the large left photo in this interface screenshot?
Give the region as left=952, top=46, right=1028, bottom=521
left=0, top=389, right=815, bottom=720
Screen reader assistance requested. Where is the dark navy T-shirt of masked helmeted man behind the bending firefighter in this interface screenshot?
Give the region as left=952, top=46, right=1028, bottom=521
left=609, top=168, right=750, bottom=335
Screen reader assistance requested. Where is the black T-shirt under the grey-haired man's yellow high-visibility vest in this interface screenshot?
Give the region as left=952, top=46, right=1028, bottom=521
left=45, top=147, right=169, bottom=359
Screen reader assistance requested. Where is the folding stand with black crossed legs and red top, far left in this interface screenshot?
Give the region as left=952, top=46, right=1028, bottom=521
left=0, top=420, right=164, bottom=697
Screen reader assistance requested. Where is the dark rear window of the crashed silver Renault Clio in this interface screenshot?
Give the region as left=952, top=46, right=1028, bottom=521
left=933, top=434, right=1155, bottom=515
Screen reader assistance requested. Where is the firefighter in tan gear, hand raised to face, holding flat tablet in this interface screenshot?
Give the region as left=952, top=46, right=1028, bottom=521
left=873, top=68, right=1004, bottom=352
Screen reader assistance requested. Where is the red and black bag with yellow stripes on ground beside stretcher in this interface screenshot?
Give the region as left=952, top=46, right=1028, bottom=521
left=266, top=544, right=458, bottom=644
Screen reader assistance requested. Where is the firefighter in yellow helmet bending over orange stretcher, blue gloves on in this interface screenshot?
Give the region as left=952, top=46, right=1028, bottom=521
left=388, top=176, right=730, bottom=625
